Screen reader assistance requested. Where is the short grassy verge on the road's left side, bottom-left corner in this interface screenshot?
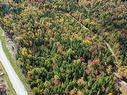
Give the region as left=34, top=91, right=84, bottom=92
left=0, top=63, right=16, bottom=95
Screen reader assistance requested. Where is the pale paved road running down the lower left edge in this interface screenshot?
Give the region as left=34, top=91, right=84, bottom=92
left=0, top=30, right=27, bottom=95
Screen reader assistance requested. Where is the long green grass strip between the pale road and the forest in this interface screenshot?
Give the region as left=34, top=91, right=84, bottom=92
left=0, top=27, right=32, bottom=95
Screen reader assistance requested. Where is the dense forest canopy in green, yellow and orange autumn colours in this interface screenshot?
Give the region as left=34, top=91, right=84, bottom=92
left=0, top=0, right=127, bottom=95
